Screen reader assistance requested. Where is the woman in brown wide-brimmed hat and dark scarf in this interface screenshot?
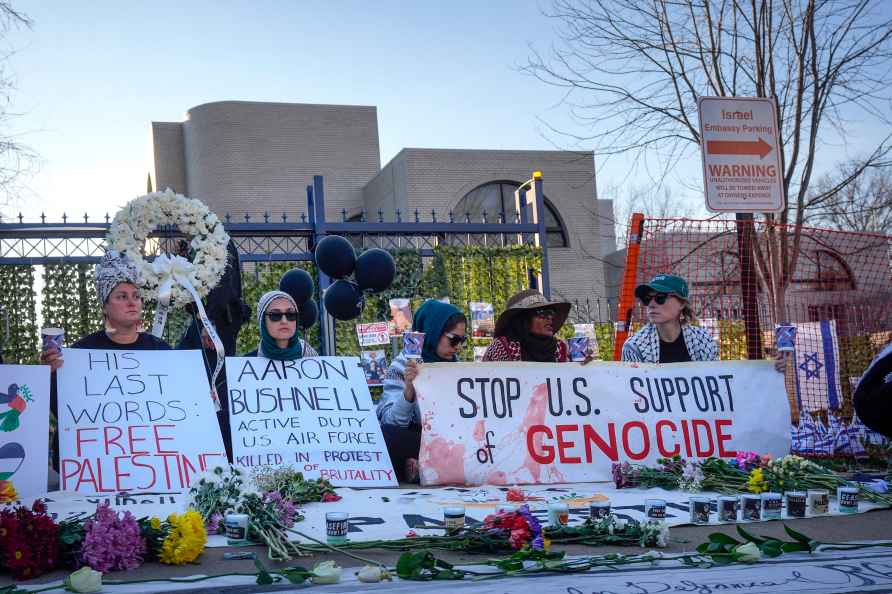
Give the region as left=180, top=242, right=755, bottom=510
left=483, top=289, right=570, bottom=363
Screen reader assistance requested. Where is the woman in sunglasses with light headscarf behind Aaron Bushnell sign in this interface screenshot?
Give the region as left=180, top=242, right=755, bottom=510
left=244, top=291, right=318, bottom=361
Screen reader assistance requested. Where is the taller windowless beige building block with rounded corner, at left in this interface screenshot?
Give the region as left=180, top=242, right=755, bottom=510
left=153, top=101, right=380, bottom=220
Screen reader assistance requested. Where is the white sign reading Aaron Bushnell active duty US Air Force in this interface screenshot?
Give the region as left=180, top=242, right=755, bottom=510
left=226, top=357, right=397, bottom=487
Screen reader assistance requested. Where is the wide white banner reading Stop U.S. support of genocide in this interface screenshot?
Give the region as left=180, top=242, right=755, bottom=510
left=415, top=361, right=790, bottom=485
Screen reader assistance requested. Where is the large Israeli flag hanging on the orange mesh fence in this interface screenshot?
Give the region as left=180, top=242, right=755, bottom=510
left=794, top=320, right=842, bottom=411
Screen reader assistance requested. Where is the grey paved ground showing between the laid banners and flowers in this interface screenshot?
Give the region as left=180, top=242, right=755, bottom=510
left=6, top=510, right=892, bottom=594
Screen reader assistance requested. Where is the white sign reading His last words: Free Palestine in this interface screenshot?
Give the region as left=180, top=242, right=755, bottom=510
left=57, top=349, right=226, bottom=493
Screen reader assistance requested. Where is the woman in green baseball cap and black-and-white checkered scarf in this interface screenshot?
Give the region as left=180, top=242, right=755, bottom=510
left=622, top=274, right=719, bottom=363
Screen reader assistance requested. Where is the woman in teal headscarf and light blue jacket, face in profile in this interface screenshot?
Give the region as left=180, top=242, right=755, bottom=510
left=376, top=299, right=468, bottom=482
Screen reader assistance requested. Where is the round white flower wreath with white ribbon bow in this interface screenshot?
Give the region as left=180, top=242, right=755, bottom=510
left=106, top=189, right=229, bottom=307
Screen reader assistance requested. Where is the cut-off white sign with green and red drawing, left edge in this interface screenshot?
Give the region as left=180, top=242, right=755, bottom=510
left=0, top=365, right=50, bottom=497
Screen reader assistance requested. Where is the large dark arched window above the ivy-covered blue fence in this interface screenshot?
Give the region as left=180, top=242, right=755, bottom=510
left=454, top=181, right=569, bottom=247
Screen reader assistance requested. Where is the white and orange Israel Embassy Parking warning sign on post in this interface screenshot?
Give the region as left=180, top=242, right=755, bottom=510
left=697, top=97, right=786, bottom=212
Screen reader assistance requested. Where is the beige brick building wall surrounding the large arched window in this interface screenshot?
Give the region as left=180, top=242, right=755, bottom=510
left=365, top=148, right=604, bottom=300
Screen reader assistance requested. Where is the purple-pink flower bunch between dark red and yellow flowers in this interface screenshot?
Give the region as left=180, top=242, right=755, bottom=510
left=81, top=501, right=146, bottom=573
